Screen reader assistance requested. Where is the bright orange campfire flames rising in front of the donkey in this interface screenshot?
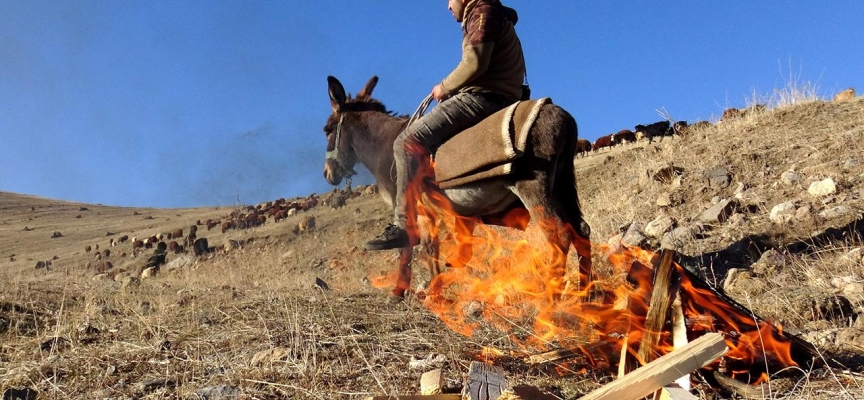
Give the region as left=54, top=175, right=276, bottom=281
left=372, top=142, right=797, bottom=379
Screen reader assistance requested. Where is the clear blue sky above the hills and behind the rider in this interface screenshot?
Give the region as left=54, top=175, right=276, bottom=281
left=0, top=0, right=864, bottom=207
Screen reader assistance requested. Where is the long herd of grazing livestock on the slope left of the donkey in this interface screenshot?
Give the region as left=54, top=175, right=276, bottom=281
left=29, top=185, right=378, bottom=276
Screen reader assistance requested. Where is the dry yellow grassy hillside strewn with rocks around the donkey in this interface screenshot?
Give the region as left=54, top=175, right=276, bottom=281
left=0, top=97, right=864, bottom=399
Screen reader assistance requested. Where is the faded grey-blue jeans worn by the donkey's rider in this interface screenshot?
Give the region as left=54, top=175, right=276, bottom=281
left=393, top=93, right=513, bottom=229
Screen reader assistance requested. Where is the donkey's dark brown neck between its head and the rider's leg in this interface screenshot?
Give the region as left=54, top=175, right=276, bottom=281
left=353, top=111, right=408, bottom=202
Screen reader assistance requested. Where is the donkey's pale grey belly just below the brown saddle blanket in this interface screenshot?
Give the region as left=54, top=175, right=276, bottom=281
left=444, top=178, right=519, bottom=216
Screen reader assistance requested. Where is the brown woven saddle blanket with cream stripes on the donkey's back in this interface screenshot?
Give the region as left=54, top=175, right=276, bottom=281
left=433, top=97, right=552, bottom=189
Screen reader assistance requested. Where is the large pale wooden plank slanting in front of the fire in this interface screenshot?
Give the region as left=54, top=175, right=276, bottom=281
left=581, top=333, right=729, bottom=400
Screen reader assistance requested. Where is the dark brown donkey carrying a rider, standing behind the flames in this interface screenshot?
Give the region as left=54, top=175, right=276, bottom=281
left=324, top=76, right=591, bottom=297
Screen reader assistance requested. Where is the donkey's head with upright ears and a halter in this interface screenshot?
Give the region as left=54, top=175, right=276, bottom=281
left=324, top=76, right=384, bottom=185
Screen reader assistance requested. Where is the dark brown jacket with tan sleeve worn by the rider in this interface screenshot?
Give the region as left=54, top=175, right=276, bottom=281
left=441, top=0, right=525, bottom=100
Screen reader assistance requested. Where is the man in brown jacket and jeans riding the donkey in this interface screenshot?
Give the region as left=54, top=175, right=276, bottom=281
left=365, top=0, right=528, bottom=250
